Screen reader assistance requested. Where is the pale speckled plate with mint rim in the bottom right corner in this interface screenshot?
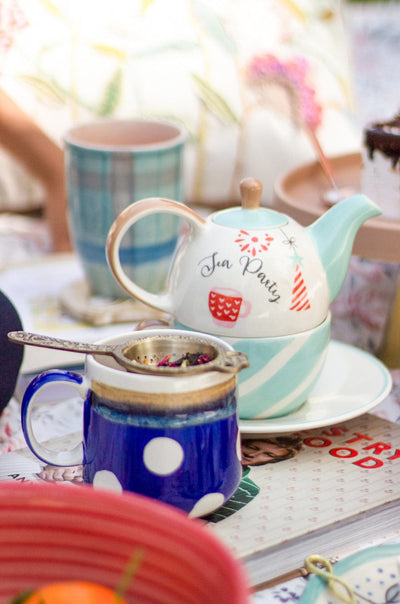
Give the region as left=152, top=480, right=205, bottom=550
left=299, top=544, right=400, bottom=604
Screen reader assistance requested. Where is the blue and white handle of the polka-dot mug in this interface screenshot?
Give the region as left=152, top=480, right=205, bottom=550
left=21, top=369, right=88, bottom=466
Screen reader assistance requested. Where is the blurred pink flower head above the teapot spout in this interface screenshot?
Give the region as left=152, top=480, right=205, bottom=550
left=247, top=53, right=322, bottom=130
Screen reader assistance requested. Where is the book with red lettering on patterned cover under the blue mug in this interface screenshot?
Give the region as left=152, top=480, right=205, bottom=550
left=209, top=414, right=400, bottom=585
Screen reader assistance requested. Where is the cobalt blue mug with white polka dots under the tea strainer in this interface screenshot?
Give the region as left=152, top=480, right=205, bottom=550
left=22, top=329, right=245, bottom=516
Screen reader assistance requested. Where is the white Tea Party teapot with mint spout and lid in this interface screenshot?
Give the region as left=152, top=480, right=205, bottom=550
left=106, top=178, right=381, bottom=338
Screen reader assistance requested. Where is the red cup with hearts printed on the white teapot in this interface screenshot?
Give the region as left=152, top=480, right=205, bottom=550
left=208, top=287, right=251, bottom=327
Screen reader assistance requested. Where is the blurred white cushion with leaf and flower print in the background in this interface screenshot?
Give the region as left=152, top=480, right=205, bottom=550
left=0, top=0, right=359, bottom=210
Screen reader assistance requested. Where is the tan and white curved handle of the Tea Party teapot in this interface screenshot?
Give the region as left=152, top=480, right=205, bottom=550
left=106, top=197, right=206, bottom=314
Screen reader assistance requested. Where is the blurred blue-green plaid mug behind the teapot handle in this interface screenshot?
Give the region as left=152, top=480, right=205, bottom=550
left=64, top=120, right=186, bottom=298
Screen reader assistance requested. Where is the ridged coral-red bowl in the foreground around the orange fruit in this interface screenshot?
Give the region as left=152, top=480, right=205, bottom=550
left=0, top=482, right=249, bottom=604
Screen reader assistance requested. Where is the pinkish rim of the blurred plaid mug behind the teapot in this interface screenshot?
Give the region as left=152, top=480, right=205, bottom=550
left=63, top=118, right=188, bottom=153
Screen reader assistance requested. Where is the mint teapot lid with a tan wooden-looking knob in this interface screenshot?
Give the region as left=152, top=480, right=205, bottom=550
left=212, top=178, right=288, bottom=229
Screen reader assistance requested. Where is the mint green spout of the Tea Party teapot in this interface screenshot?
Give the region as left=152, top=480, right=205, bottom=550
left=307, top=194, right=382, bottom=302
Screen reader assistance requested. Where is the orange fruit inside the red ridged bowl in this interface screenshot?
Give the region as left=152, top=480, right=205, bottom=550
left=18, top=581, right=127, bottom=604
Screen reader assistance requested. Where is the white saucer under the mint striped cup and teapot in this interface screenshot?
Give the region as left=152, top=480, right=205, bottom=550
left=239, top=340, right=392, bottom=434
